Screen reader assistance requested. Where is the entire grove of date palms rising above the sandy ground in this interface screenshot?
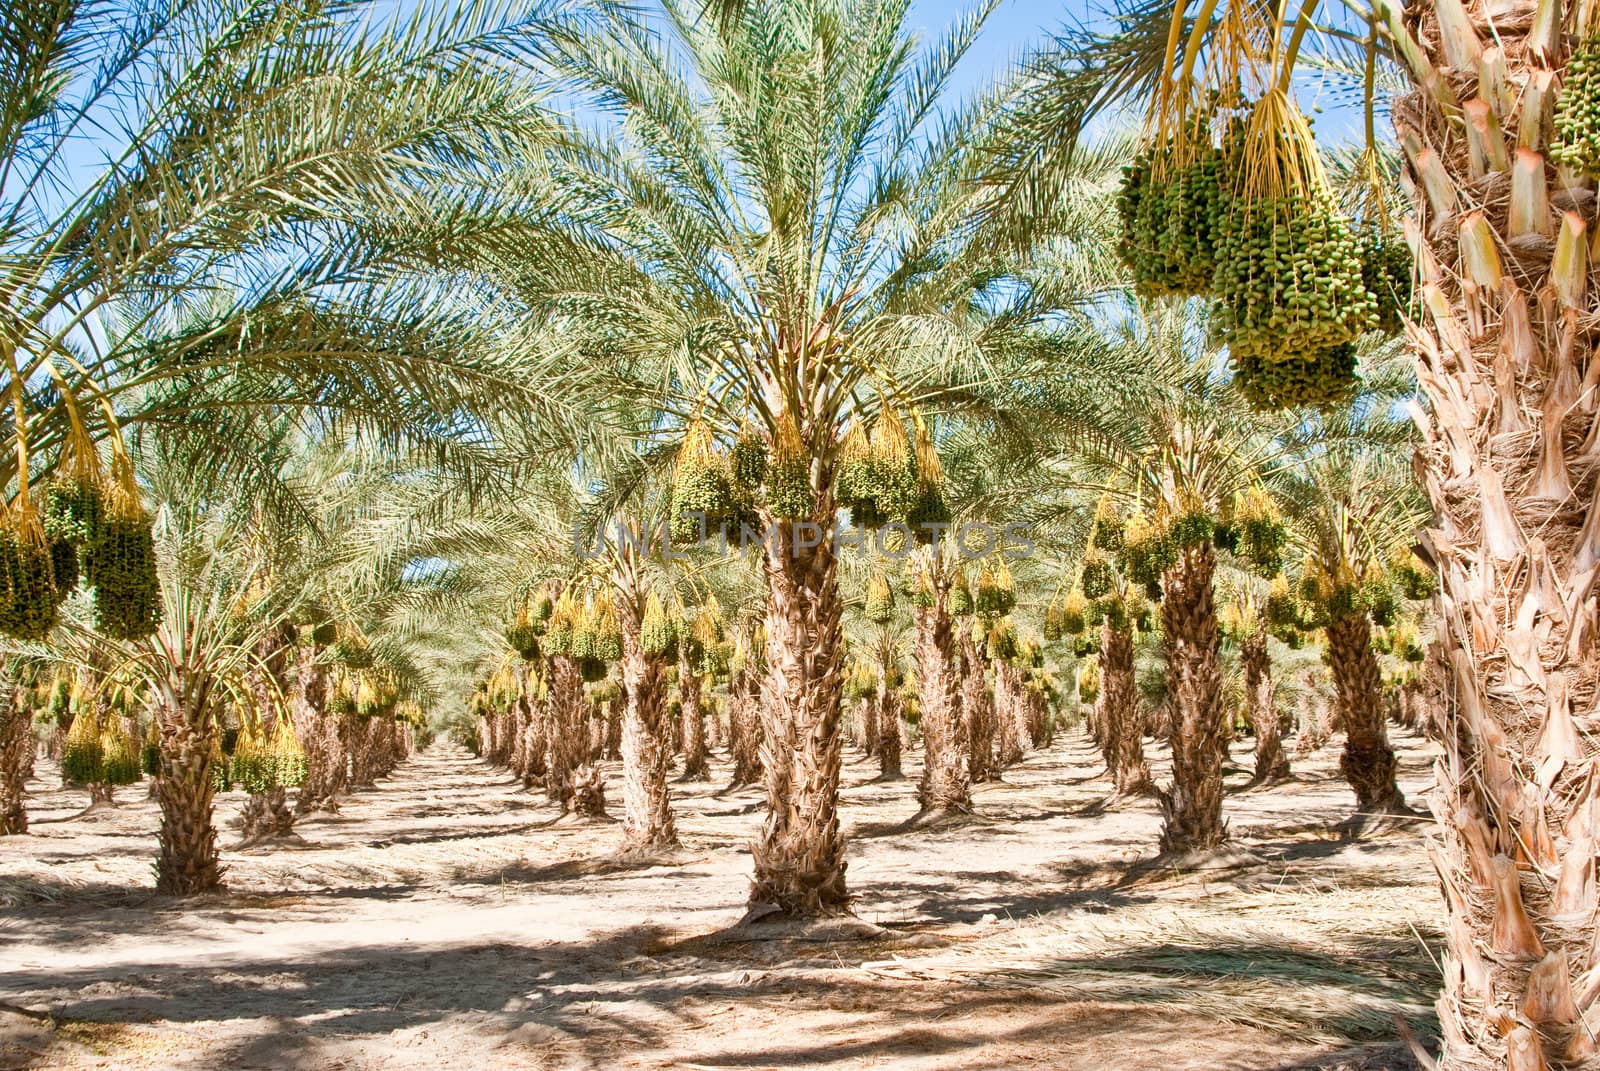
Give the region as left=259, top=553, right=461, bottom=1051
left=0, top=0, right=1600, bottom=1069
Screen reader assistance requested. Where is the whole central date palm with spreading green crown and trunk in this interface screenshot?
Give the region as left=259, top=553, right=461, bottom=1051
left=498, top=0, right=1139, bottom=916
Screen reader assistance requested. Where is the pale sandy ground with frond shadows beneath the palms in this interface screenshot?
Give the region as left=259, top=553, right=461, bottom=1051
left=0, top=717, right=1438, bottom=1071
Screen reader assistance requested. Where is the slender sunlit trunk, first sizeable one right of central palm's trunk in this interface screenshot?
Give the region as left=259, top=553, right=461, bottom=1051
left=914, top=588, right=973, bottom=813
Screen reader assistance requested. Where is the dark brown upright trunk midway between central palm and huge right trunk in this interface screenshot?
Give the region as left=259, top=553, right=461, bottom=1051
left=1160, top=544, right=1227, bottom=852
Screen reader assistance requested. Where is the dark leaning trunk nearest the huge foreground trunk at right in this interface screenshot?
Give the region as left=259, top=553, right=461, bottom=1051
left=1323, top=612, right=1408, bottom=816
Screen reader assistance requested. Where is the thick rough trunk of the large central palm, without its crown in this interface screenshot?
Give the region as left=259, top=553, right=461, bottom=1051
left=750, top=504, right=850, bottom=917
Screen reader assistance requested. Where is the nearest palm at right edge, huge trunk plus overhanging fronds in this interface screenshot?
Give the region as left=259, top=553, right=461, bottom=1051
left=1019, top=0, right=1600, bottom=1050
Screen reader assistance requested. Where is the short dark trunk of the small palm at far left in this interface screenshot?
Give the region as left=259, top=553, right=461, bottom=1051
left=155, top=672, right=222, bottom=897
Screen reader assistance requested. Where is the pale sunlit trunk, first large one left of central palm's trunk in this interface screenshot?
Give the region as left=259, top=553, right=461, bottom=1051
left=618, top=588, right=678, bottom=855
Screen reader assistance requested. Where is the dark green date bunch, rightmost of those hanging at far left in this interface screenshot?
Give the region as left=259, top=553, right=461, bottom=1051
left=83, top=450, right=162, bottom=640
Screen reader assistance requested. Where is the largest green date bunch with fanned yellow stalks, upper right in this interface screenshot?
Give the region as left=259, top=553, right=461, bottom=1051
left=1211, top=86, right=1378, bottom=407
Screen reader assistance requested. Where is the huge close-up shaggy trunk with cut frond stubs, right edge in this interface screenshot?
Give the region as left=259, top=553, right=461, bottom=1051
left=1390, top=16, right=1600, bottom=1071
